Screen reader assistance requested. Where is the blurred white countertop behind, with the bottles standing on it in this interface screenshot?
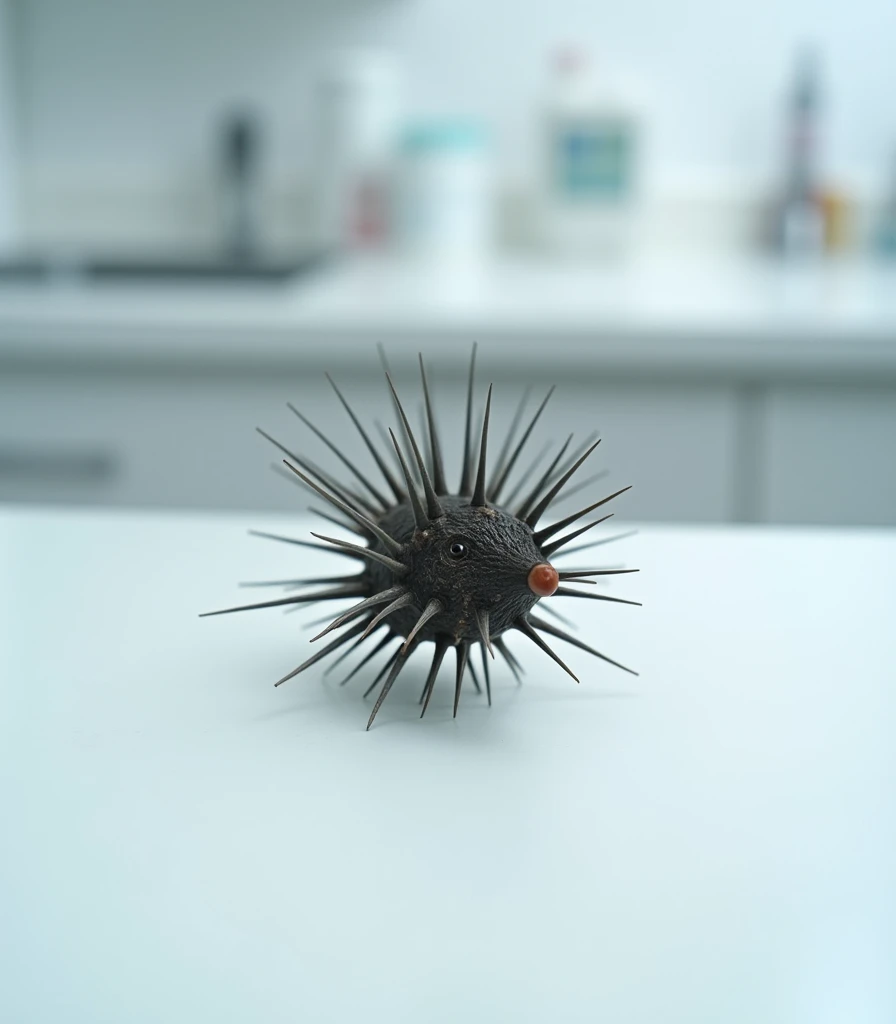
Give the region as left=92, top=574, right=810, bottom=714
left=0, top=255, right=896, bottom=374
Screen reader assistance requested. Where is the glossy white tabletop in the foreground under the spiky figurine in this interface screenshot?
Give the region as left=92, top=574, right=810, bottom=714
left=0, top=509, right=896, bottom=1024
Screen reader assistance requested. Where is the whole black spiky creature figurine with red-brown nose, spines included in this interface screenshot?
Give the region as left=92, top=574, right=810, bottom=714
left=207, top=346, right=638, bottom=729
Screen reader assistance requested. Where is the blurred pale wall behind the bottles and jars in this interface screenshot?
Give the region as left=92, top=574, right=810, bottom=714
left=8, top=0, right=896, bottom=223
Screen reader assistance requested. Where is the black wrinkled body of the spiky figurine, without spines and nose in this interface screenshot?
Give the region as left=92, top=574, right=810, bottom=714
left=369, top=496, right=546, bottom=642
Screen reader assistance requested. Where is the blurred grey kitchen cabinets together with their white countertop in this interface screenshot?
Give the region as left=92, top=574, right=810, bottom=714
left=0, top=261, right=896, bottom=524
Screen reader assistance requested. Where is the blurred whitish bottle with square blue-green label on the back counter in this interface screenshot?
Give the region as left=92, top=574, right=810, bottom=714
left=538, top=50, right=642, bottom=256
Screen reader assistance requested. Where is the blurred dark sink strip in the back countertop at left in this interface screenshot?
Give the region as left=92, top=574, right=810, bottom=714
left=0, top=252, right=327, bottom=285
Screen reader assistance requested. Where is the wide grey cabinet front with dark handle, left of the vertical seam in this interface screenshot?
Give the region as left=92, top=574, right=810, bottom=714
left=0, top=360, right=735, bottom=521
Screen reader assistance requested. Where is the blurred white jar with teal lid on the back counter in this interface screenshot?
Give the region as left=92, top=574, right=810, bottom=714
left=395, top=121, right=494, bottom=264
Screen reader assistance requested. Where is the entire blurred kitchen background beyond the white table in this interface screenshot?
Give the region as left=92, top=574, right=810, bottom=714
left=0, top=0, right=896, bottom=525
